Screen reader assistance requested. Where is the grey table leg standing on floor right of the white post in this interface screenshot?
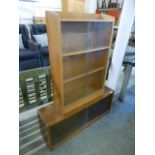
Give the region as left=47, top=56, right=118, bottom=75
left=119, top=64, right=133, bottom=102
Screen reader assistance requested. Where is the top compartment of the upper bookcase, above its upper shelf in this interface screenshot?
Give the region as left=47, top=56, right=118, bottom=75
left=62, top=22, right=112, bottom=53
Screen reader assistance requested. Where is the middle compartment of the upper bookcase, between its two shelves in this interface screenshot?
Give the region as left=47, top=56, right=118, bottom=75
left=63, top=50, right=109, bottom=83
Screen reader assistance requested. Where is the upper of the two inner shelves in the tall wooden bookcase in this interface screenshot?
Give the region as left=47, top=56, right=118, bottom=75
left=63, top=46, right=109, bottom=57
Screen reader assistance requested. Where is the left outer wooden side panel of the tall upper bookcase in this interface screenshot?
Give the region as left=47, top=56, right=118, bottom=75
left=46, top=11, right=64, bottom=111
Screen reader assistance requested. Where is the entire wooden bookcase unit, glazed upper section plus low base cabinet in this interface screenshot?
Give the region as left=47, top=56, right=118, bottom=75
left=38, top=11, right=114, bottom=149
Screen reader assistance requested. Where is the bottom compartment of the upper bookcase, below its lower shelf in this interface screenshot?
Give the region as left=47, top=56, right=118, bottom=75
left=64, top=69, right=105, bottom=106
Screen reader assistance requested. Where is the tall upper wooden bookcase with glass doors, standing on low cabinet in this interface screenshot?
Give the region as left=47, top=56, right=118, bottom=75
left=46, top=11, right=114, bottom=115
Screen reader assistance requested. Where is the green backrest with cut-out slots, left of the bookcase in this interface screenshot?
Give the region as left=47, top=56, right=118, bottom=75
left=19, top=67, right=52, bottom=112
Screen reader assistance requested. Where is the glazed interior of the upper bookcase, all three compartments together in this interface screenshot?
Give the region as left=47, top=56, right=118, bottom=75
left=61, top=22, right=112, bottom=106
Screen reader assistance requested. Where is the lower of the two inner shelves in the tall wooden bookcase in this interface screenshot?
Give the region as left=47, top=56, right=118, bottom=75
left=64, top=67, right=105, bottom=83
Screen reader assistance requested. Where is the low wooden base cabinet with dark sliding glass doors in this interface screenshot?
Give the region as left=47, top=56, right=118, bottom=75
left=38, top=87, right=114, bottom=149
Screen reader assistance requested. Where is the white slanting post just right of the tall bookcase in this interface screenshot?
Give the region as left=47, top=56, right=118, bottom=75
left=106, top=0, right=135, bottom=90
